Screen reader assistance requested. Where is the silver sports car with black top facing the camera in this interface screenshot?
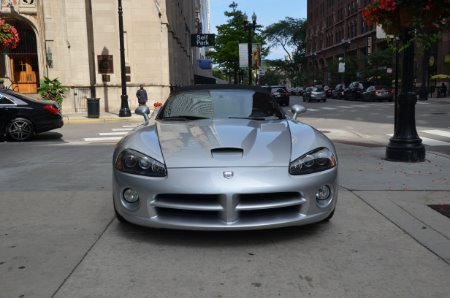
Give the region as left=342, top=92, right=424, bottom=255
left=113, top=85, right=338, bottom=230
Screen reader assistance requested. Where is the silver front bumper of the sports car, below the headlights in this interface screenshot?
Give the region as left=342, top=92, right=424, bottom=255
left=113, top=167, right=338, bottom=230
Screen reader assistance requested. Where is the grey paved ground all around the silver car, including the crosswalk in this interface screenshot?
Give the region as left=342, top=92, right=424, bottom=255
left=0, top=97, right=450, bottom=298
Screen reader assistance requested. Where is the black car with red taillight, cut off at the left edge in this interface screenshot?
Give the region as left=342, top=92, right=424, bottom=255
left=0, top=90, right=64, bottom=141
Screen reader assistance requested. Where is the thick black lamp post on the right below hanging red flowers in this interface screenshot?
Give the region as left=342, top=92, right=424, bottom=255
left=386, top=30, right=425, bottom=162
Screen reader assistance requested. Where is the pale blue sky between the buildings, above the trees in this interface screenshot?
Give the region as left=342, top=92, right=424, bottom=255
left=210, top=0, right=307, bottom=59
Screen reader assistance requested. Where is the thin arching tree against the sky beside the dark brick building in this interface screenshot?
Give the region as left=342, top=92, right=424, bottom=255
left=263, top=17, right=306, bottom=85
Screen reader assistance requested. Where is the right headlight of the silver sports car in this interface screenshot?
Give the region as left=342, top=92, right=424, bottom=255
left=289, top=148, right=337, bottom=175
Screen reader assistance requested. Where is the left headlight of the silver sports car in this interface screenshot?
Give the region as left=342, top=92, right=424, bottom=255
left=114, top=149, right=167, bottom=177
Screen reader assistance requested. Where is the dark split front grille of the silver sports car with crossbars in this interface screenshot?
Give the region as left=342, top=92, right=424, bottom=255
left=151, top=192, right=306, bottom=225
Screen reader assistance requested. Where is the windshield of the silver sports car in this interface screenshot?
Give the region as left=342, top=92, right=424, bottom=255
left=157, top=89, right=284, bottom=121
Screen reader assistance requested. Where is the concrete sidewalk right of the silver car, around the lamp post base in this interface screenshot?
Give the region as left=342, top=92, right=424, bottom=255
left=336, top=143, right=450, bottom=264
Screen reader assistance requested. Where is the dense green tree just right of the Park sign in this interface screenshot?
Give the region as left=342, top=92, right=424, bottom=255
left=207, top=2, right=265, bottom=84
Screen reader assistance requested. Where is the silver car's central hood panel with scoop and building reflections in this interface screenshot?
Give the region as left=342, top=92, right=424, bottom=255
left=157, top=119, right=291, bottom=168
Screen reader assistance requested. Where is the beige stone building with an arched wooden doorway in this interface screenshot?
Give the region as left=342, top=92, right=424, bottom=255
left=0, top=0, right=209, bottom=113
